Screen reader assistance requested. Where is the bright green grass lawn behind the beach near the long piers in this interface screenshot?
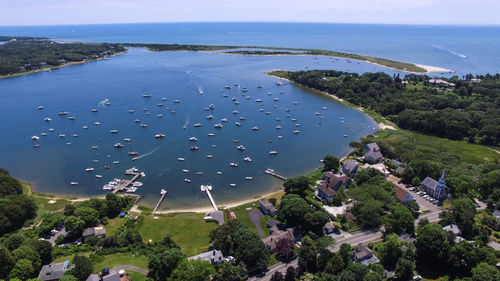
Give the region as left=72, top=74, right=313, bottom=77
left=138, top=213, right=218, bottom=257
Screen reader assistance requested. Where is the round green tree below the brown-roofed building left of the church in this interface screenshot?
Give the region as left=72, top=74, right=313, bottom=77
left=383, top=204, right=415, bottom=234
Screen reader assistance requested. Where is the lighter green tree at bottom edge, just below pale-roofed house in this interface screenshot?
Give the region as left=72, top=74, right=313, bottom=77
left=168, top=260, right=215, bottom=281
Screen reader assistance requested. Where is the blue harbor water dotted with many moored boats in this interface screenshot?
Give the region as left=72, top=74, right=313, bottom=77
left=0, top=49, right=378, bottom=208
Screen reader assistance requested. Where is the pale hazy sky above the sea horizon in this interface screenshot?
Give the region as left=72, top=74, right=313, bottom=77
left=0, top=0, right=500, bottom=26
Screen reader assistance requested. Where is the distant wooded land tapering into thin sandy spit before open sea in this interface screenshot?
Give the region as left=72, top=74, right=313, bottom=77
left=0, top=36, right=453, bottom=78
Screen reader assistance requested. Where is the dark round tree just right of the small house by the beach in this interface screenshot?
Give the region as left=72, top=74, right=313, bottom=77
left=278, top=194, right=313, bottom=226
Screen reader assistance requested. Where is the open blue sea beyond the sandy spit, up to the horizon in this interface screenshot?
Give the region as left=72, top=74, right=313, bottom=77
left=0, top=23, right=500, bottom=75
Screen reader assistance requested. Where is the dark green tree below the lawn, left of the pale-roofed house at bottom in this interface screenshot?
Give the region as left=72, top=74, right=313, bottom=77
left=148, top=248, right=188, bottom=280
